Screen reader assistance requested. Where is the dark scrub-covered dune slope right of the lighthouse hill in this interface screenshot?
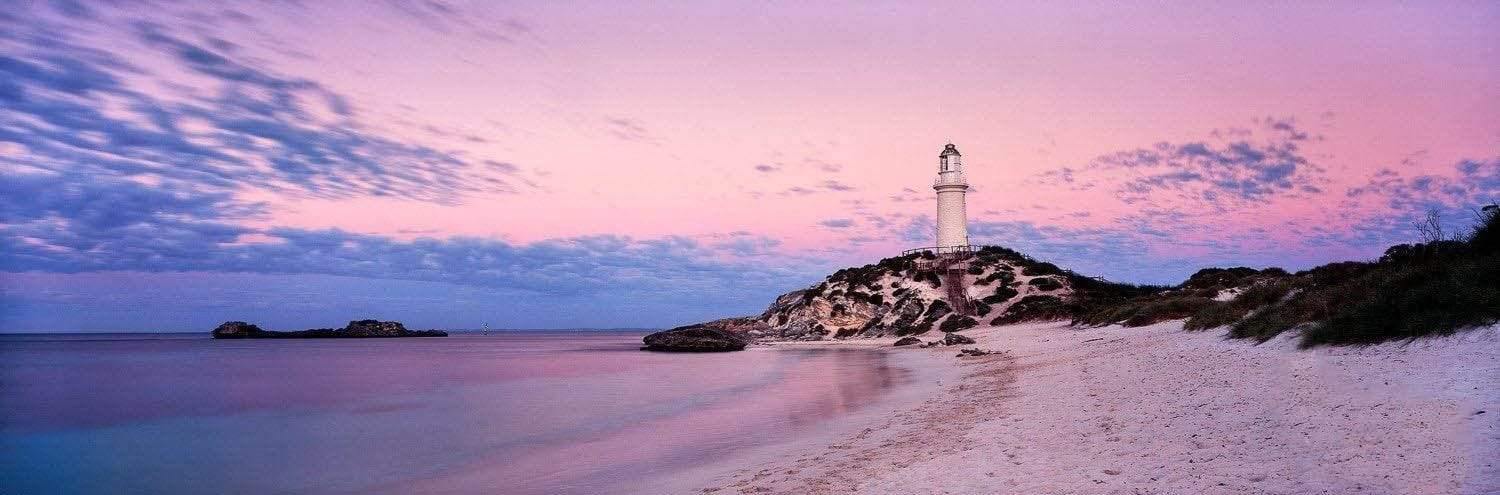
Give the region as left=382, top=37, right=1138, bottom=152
left=1074, top=215, right=1500, bottom=347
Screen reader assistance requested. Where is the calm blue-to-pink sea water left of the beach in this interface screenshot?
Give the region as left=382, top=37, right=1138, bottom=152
left=0, top=332, right=908, bottom=494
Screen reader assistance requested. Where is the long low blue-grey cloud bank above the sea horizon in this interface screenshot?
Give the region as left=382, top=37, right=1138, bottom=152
left=0, top=164, right=816, bottom=296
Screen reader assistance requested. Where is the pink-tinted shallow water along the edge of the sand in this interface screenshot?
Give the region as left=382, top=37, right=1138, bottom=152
left=383, top=350, right=911, bottom=494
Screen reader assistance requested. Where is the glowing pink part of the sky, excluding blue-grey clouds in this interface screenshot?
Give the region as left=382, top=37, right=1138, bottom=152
left=252, top=3, right=1500, bottom=249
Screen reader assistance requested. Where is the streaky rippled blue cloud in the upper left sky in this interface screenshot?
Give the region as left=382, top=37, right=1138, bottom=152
left=0, top=7, right=524, bottom=204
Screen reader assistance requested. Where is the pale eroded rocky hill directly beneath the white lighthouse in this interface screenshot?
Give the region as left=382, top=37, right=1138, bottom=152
left=755, top=248, right=1073, bottom=341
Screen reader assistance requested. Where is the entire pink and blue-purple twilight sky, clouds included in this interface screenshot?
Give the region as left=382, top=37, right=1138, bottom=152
left=0, top=0, right=1500, bottom=332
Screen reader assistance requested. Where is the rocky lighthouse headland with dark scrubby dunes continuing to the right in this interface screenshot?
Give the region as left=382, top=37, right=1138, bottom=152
left=708, top=209, right=1500, bottom=347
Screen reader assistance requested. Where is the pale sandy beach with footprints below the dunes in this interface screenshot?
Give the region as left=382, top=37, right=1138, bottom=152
left=678, top=323, right=1500, bottom=494
